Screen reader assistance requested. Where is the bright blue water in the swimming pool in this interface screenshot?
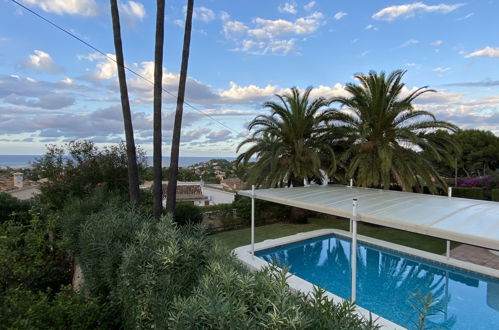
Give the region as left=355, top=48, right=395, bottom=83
left=256, top=235, right=499, bottom=330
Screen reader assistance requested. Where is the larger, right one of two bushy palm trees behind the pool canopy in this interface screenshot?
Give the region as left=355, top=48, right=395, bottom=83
left=327, top=70, right=458, bottom=192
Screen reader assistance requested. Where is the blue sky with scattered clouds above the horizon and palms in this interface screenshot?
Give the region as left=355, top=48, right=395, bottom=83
left=0, top=0, right=499, bottom=157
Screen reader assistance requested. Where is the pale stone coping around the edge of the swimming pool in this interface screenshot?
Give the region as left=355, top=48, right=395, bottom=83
left=233, top=229, right=499, bottom=329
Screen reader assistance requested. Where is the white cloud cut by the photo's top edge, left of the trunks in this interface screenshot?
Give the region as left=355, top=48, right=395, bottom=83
left=23, top=0, right=97, bottom=16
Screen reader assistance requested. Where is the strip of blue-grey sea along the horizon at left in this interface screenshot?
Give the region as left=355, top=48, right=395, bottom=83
left=0, top=155, right=236, bottom=168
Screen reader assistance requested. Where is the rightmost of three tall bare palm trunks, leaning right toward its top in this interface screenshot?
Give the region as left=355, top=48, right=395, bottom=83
left=166, top=0, right=194, bottom=214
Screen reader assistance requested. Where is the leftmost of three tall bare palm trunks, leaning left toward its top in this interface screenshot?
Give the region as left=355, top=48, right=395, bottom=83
left=110, top=0, right=140, bottom=205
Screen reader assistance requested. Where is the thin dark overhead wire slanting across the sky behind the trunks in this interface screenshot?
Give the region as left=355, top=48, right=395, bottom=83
left=10, top=0, right=241, bottom=135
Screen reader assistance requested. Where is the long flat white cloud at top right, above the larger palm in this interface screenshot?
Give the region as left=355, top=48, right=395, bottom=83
left=372, top=2, right=463, bottom=21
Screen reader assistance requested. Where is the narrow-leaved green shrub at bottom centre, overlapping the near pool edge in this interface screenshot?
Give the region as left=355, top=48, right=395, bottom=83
left=168, top=249, right=377, bottom=329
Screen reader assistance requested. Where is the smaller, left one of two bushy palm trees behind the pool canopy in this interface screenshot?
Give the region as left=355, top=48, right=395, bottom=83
left=237, top=87, right=335, bottom=187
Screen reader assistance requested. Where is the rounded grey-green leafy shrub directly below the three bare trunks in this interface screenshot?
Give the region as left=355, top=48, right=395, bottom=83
left=117, top=217, right=211, bottom=329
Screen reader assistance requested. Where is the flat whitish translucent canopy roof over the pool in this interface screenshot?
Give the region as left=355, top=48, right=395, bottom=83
left=238, top=185, right=499, bottom=250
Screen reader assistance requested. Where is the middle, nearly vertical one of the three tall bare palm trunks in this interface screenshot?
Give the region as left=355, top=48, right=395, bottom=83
left=153, top=0, right=165, bottom=219
